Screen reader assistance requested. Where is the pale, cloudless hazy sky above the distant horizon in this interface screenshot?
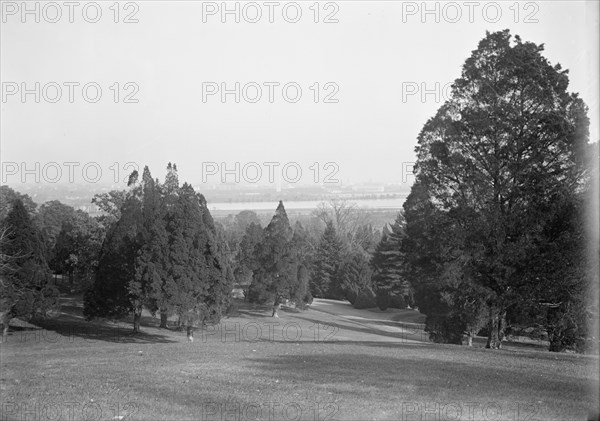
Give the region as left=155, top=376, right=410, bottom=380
left=0, top=1, right=599, bottom=185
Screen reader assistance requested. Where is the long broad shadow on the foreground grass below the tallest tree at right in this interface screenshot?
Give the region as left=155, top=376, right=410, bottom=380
left=246, top=352, right=594, bottom=418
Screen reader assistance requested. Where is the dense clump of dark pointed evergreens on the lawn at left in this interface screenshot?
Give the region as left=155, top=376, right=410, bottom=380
left=84, top=163, right=233, bottom=332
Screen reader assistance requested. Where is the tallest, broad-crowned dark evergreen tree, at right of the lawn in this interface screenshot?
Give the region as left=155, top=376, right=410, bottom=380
left=404, top=31, right=588, bottom=348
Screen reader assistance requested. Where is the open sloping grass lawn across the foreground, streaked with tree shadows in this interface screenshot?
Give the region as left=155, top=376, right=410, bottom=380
left=0, top=297, right=598, bottom=420
